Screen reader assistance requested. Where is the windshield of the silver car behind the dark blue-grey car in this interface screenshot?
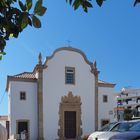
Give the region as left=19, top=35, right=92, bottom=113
left=111, top=122, right=136, bottom=132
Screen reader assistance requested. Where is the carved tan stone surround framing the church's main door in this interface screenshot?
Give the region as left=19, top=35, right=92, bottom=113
left=58, top=92, right=82, bottom=140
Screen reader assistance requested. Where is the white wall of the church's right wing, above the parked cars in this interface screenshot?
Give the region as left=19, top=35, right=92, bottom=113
left=98, top=87, right=116, bottom=128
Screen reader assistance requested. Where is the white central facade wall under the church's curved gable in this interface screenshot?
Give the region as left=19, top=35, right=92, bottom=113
left=43, top=50, right=95, bottom=140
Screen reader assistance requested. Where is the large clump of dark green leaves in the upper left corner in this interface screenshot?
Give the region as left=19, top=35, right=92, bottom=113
left=0, top=0, right=47, bottom=60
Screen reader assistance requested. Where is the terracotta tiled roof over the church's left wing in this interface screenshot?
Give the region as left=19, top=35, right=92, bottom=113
left=12, top=72, right=36, bottom=79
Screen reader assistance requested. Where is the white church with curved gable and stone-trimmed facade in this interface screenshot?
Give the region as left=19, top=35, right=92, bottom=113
left=6, top=47, right=115, bottom=140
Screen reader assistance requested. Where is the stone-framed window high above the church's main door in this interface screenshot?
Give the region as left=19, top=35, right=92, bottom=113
left=65, top=67, right=75, bottom=84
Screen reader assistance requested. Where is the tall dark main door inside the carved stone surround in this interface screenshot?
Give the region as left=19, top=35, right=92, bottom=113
left=64, top=111, right=76, bottom=139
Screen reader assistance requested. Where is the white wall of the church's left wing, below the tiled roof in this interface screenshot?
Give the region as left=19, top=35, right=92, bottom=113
left=9, top=81, right=38, bottom=140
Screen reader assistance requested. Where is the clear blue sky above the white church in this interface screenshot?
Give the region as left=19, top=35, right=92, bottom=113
left=0, top=0, right=140, bottom=115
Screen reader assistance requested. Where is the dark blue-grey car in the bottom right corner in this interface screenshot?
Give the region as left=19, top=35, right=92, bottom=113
left=109, top=122, right=140, bottom=140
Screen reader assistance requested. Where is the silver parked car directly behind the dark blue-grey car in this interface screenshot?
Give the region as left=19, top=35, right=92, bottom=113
left=88, top=120, right=138, bottom=140
